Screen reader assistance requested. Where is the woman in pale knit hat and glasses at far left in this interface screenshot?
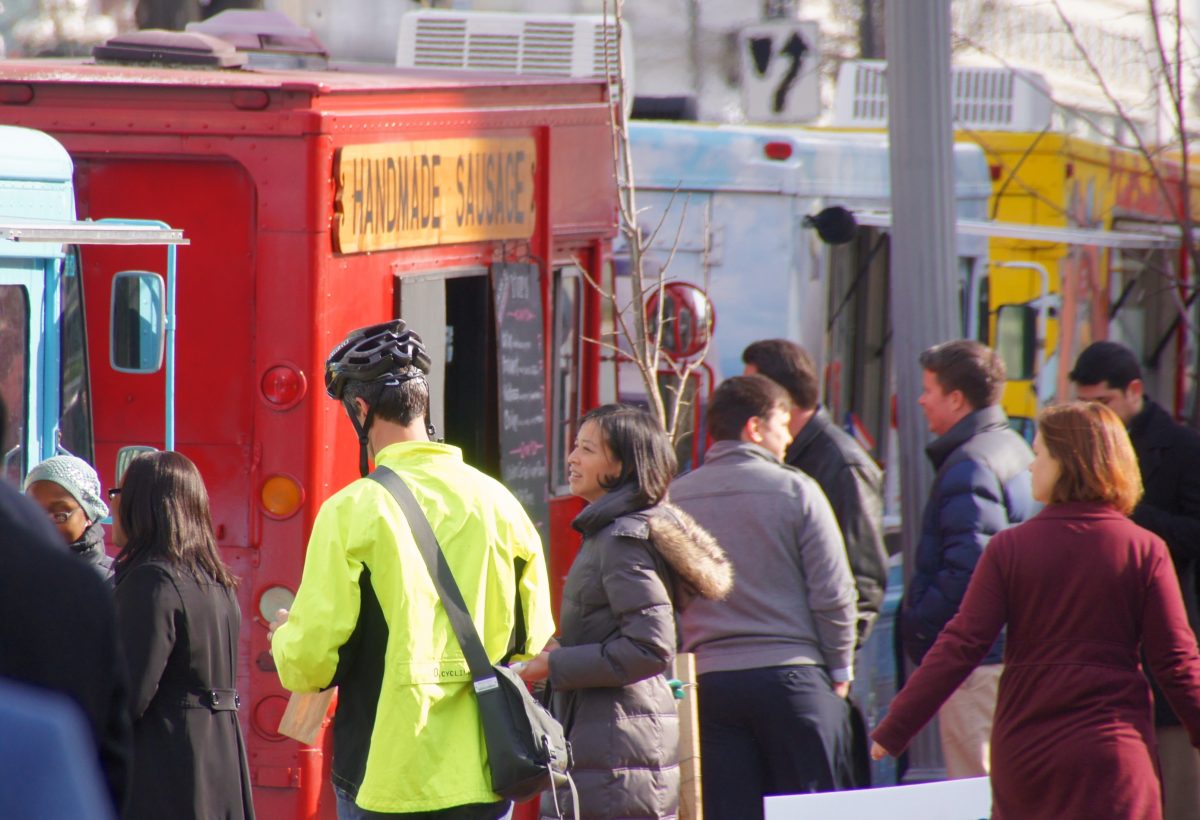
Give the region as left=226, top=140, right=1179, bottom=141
left=25, top=455, right=113, bottom=582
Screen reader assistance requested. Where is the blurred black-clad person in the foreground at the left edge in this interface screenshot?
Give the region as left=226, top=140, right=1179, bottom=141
left=0, top=402, right=132, bottom=816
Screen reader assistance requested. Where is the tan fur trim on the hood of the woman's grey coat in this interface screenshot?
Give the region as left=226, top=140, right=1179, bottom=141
left=646, top=502, right=733, bottom=600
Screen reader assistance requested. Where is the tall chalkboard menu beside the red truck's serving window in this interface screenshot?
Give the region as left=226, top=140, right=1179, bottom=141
left=492, top=264, right=550, bottom=544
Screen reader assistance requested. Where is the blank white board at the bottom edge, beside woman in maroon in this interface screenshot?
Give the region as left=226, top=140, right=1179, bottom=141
left=763, top=777, right=991, bottom=820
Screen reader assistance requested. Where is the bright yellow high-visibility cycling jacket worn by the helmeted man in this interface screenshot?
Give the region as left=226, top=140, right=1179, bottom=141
left=271, top=442, right=554, bottom=813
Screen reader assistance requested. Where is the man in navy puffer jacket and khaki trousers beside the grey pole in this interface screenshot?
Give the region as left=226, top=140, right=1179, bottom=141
left=900, top=339, right=1034, bottom=779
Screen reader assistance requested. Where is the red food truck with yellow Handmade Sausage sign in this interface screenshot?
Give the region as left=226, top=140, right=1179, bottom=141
left=0, top=32, right=616, bottom=818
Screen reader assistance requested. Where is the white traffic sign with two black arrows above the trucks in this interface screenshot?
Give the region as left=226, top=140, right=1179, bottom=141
left=738, top=20, right=821, bottom=122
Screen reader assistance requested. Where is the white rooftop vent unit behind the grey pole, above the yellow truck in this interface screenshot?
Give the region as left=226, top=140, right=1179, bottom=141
left=833, top=60, right=1054, bottom=131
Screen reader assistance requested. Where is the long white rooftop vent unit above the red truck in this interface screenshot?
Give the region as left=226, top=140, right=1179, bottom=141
left=396, top=10, right=634, bottom=88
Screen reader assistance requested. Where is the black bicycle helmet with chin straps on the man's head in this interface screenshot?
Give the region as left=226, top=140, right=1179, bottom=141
left=325, top=319, right=437, bottom=475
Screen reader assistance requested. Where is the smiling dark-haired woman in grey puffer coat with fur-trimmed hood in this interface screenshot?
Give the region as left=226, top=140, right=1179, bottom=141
left=522, top=405, right=733, bottom=820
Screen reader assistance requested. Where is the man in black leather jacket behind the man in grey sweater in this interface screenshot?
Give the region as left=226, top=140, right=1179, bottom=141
left=742, top=339, right=888, bottom=647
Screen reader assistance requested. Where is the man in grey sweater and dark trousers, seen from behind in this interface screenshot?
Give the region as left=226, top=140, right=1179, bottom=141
left=671, top=375, right=857, bottom=819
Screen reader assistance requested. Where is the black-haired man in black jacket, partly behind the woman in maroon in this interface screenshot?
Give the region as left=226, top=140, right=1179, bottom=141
left=1070, top=342, right=1200, bottom=820
